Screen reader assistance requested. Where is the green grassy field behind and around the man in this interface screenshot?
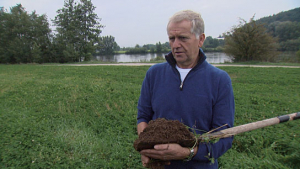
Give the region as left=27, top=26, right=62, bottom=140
left=0, top=65, right=300, bottom=169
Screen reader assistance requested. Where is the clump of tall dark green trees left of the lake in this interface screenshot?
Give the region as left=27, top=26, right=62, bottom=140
left=0, top=0, right=118, bottom=63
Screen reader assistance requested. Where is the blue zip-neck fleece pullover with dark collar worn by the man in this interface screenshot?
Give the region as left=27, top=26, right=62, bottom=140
left=137, top=49, right=234, bottom=169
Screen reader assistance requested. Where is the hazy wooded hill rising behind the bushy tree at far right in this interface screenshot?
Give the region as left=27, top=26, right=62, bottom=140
left=256, top=8, right=300, bottom=51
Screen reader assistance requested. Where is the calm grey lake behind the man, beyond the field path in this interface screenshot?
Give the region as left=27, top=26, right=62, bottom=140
left=94, top=52, right=231, bottom=63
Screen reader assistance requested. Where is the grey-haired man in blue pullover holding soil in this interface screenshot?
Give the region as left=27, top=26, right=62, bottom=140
left=137, top=10, right=234, bottom=169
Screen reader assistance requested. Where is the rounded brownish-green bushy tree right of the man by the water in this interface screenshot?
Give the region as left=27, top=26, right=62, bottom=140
left=224, top=16, right=276, bottom=61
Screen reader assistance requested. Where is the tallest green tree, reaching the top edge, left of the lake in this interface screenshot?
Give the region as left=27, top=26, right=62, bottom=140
left=53, top=0, right=103, bottom=62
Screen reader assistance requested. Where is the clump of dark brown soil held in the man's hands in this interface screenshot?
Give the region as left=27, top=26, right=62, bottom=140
left=133, top=118, right=195, bottom=151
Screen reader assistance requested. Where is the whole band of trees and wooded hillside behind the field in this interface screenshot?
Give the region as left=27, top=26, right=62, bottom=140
left=0, top=0, right=300, bottom=63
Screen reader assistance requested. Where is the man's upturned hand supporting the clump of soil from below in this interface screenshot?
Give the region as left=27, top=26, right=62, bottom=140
left=140, top=144, right=190, bottom=161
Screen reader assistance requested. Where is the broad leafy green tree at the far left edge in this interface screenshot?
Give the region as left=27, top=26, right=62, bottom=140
left=0, top=4, right=51, bottom=63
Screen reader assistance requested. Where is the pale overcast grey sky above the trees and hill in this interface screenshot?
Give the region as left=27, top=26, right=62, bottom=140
left=0, top=0, right=300, bottom=47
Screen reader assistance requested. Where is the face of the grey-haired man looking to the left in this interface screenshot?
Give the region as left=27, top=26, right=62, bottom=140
left=167, top=20, right=205, bottom=68
